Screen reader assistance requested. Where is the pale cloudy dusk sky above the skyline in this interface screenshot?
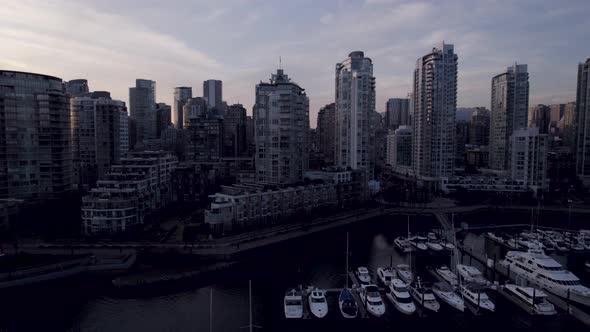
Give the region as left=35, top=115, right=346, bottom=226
left=0, top=0, right=590, bottom=127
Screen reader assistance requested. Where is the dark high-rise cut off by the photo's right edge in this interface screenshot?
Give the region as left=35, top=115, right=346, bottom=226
left=575, top=58, right=590, bottom=185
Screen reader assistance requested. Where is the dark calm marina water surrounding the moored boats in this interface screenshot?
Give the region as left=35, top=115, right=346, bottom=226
left=0, top=217, right=584, bottom=332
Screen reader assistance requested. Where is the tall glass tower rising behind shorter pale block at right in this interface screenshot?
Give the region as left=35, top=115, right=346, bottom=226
left=490, top=64, right=529, bottom=170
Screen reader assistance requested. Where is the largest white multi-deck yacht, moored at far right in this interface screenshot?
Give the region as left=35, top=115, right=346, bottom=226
left=502, top=250, right=590, bottom=306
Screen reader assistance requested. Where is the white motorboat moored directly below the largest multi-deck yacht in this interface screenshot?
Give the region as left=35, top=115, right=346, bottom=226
left=501, top=284, right=557, bottom=316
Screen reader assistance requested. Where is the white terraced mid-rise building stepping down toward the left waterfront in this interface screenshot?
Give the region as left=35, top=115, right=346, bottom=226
left=82, top=151, right=178, bottom=235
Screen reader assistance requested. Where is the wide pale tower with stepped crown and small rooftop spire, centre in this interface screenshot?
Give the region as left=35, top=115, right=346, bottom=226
left=254, top=69, right=309, bottom=184
